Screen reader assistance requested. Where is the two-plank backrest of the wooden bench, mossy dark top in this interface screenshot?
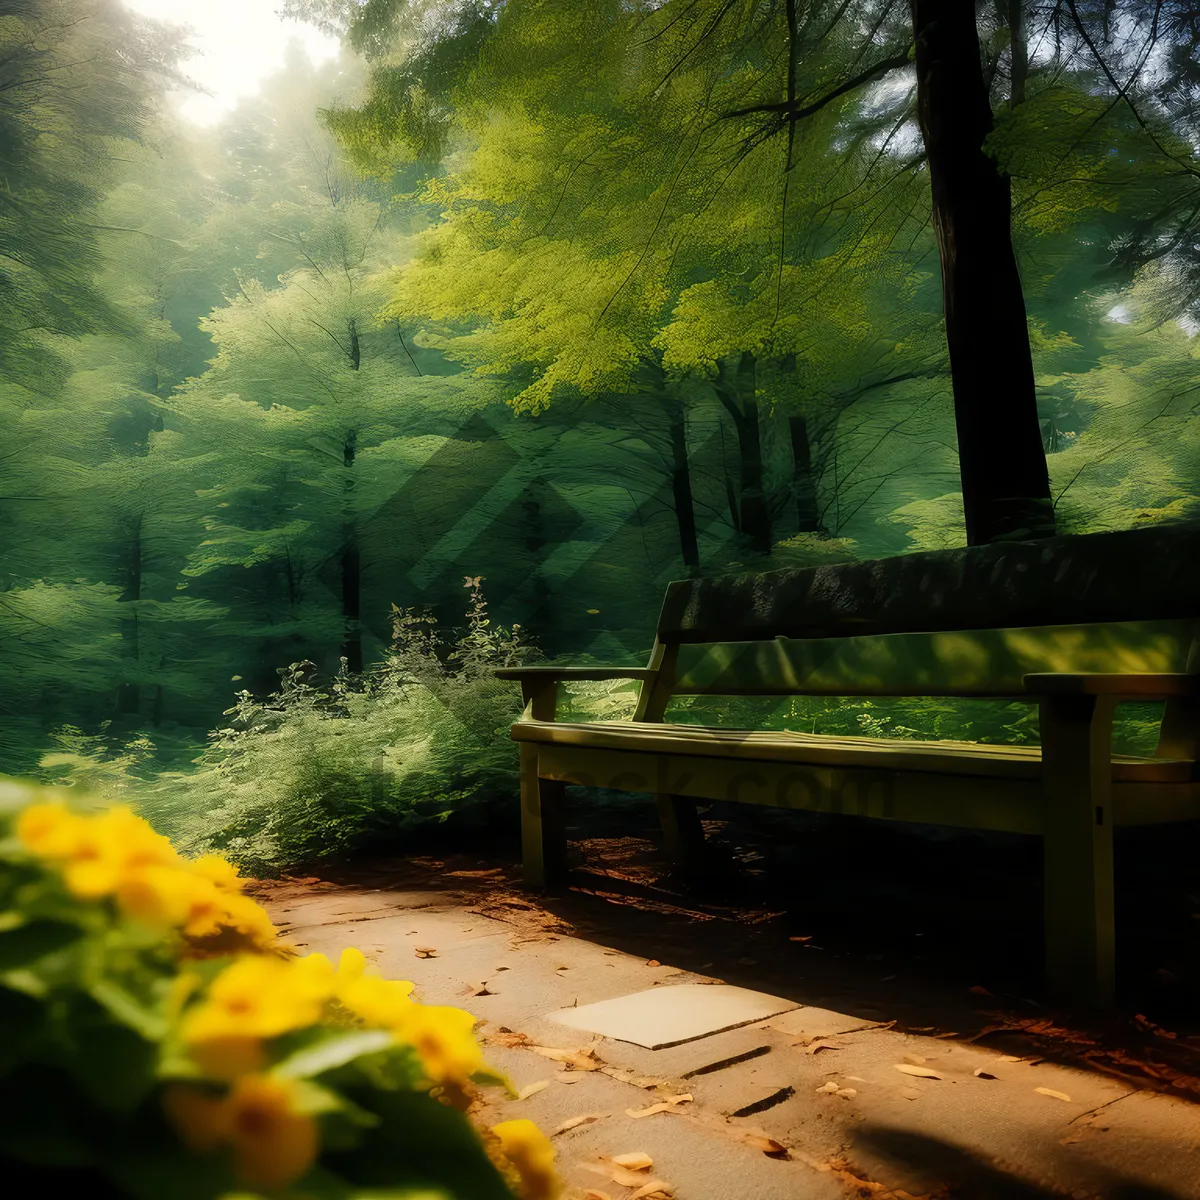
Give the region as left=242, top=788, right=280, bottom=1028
left=643, top=524, right=1200, bottom=744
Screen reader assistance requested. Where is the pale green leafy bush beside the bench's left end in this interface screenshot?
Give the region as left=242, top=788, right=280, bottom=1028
left=135, top=577, right=529, bottom=875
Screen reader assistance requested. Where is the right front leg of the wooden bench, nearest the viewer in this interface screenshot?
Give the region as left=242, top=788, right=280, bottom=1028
left=1040, top=696, right=1115, bottom=1007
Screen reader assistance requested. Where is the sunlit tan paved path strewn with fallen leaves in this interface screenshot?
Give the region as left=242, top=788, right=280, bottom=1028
left=250, top=858, right=1200, bottom=1200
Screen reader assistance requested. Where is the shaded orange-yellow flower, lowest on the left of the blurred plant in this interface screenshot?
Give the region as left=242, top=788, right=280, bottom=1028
left=163, top=1075, right=319, bottom=1189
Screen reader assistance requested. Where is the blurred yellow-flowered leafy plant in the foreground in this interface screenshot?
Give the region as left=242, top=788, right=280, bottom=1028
left=0, top=782, right=558, bottom=1200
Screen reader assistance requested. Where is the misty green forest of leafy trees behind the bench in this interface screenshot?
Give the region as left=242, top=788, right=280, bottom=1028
left=0, top=0, right=1200, bottom=870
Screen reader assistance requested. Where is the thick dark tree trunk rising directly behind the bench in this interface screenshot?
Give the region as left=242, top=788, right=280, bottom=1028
left=910, top=0, right=1054, bottom=545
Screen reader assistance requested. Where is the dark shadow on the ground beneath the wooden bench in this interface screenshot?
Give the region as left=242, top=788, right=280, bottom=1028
left=307, top=804, right=1200, bottom=1104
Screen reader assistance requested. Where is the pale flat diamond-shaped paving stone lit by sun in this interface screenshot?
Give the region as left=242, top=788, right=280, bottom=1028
left=550, top=983, right=797, bottom=1050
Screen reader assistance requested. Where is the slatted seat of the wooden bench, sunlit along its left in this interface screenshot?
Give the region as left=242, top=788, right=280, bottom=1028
left=512, top=720, right=1198, bottom=784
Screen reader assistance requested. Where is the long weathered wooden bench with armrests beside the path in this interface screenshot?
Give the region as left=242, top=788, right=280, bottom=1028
left=497, top=526, right=1200, bottom=1004
